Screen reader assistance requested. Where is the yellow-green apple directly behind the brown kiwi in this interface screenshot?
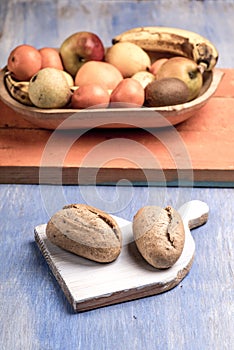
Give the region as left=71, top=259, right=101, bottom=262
left=156, top=56, right=203, bottom=101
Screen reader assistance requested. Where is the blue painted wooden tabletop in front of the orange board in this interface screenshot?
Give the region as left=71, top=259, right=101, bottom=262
left=0, top=185, right=234, bottom=350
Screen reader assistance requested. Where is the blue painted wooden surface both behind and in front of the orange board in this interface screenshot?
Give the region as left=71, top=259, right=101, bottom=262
left=0, top=0, right=234, bottom=350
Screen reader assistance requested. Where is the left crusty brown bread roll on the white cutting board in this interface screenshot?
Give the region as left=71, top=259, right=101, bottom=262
left=46, top=204, right=122, bottom=263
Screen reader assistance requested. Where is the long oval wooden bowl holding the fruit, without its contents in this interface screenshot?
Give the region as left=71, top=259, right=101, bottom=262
left=0, top=69, right=224, bottom=130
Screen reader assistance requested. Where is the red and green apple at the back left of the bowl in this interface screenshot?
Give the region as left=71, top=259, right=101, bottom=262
left=59, top=31, right=105, bottom=77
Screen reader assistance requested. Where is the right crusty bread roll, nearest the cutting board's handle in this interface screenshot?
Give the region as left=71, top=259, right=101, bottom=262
left=133, top=206, right=185, bottom=269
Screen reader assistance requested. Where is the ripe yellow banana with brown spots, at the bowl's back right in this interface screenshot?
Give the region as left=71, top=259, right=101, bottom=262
left=112, top=27, right=219, bottom=70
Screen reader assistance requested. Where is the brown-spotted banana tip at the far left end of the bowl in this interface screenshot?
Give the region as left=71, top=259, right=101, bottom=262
left=4, top=71, right=33, bottom=106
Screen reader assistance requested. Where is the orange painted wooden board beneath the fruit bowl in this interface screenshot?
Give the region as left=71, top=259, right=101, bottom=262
left=0, top=69, right=234, bottom=186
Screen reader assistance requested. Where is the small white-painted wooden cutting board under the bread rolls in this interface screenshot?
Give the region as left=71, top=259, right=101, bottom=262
left=35, top=200, right=209, bottom=312
